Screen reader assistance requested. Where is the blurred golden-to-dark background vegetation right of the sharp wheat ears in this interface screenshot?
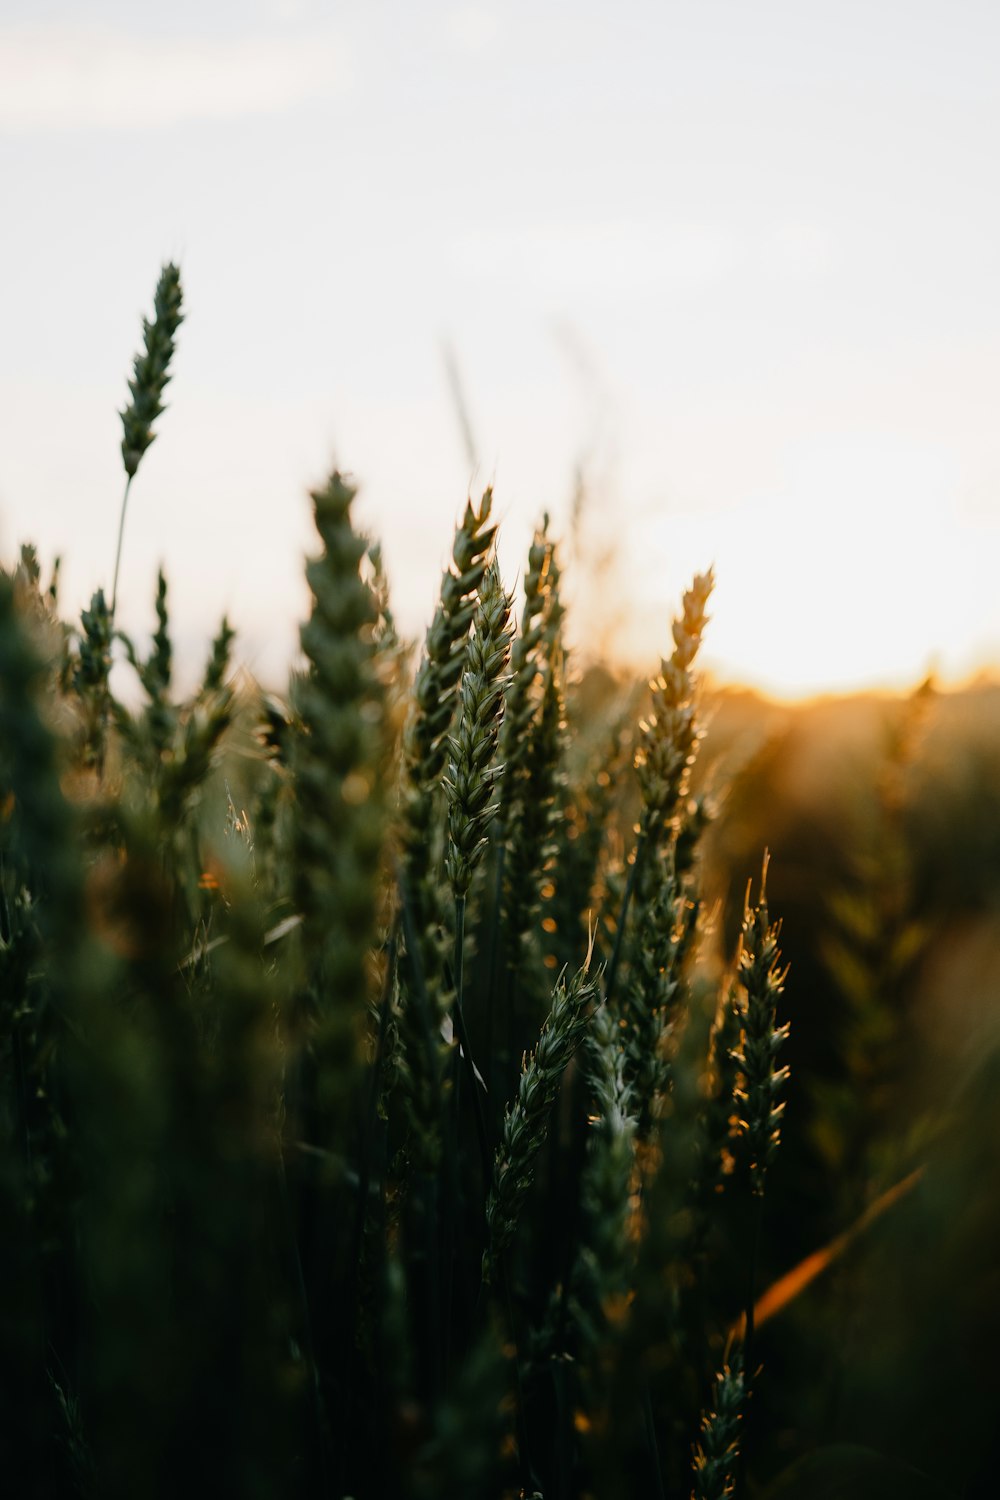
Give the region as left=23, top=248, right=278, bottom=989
left=542, top=665, right=1000, bottom=1496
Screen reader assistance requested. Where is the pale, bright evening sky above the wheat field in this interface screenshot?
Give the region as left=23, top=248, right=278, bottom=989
left=0, top=0, right=1000, bottom=696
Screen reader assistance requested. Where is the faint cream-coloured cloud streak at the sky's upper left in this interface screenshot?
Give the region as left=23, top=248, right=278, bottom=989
left=0, top=27, right=351, bottom=134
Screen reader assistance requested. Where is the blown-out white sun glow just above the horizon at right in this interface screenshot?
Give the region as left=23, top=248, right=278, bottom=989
left=624, top=429, right=997, bottom=698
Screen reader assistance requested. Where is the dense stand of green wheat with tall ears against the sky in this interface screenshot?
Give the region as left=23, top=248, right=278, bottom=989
left=0, top=266, right=1000, bottom=1500
